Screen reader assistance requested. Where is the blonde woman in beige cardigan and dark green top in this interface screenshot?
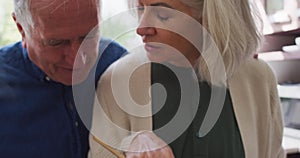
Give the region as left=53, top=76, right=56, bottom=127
left=90, top=0, right=284, bottom=158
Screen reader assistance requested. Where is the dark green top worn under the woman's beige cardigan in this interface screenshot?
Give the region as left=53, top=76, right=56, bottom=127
left=151, top=64, right=245, bottom=158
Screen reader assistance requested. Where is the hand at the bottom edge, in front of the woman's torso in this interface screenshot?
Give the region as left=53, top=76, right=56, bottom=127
left=125, top=132, right=174, bottom=158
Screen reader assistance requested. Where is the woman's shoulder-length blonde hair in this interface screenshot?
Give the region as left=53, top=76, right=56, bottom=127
left=181, top=0, right=262, bottom=80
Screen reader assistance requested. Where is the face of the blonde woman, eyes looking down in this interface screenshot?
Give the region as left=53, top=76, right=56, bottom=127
left=137, top=0, right=200, bottom=67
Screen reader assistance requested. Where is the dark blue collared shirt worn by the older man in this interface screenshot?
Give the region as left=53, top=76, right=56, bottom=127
left=0, top=39, right=126, bottom=158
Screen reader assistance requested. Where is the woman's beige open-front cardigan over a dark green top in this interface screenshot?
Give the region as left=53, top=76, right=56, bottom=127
left=89, top=55, right=285, bottom=158
